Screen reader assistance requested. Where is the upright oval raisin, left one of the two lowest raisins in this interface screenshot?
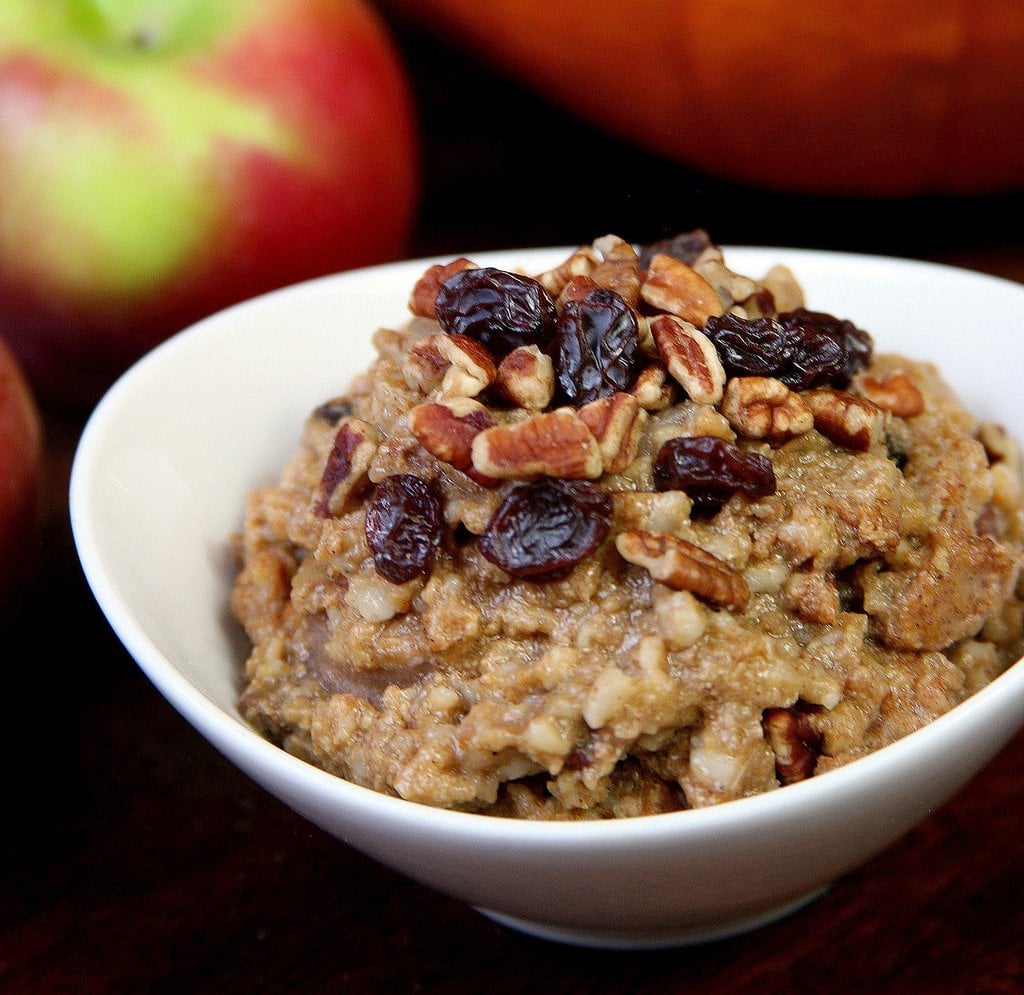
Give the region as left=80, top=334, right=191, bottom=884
left=366, top=473, right=444, bottom=583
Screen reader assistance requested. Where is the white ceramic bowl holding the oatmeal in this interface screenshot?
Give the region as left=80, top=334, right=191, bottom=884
left=71, top=248, right=1024, bottom=947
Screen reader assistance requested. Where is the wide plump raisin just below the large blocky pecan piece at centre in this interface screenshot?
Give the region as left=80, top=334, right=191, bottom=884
left=480, top=477, right=611, bottom=580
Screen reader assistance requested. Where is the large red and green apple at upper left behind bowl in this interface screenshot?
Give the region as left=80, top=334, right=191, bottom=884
left=0, top=0, right=419, bottom=405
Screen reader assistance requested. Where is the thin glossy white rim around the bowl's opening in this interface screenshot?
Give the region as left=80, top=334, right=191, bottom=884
left=69, top=245, right=1024, bottom=846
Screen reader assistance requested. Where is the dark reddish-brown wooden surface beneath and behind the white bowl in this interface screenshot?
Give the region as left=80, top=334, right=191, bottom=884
left=0, top=17, right=1024, bottom=995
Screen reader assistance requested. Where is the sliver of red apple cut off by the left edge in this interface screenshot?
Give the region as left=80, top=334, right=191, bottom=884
left=0, top=333, right=43, bottom=606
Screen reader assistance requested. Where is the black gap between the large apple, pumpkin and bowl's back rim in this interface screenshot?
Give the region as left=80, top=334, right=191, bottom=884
left=390, top=5, right=1024, bottom=275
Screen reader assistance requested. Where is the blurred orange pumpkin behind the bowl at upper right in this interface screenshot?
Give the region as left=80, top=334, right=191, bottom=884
left=382, top=0, right=1024, bottom=196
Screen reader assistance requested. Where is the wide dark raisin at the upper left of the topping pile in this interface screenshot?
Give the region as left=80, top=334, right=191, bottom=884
left=434, top=266, right=557, bottom=356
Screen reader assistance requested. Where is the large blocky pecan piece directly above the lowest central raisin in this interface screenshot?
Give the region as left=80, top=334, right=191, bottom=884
left=473, top=407, right=604, bottom=480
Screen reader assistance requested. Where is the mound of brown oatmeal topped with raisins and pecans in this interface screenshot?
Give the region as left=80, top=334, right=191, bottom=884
left=231, top=231, right=1024, bottom=819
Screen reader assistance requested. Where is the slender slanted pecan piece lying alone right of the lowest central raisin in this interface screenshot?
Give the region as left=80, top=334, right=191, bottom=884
left=615, top=529, right=750, bottom=609
